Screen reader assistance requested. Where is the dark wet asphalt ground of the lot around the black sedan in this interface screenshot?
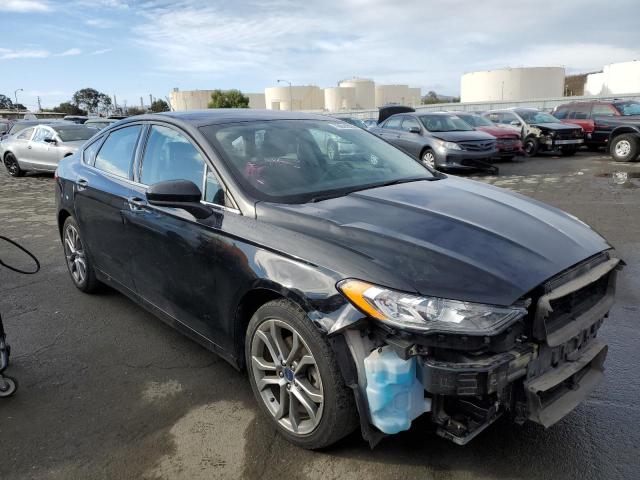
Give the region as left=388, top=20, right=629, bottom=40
left=0, top=152, right=640, bottom=479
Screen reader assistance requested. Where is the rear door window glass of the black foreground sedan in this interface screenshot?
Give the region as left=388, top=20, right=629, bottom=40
left=95, top=125, right=142, bottom=178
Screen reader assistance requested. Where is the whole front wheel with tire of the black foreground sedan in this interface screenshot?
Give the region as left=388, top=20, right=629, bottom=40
left=245, top=299, right=358, bottom=449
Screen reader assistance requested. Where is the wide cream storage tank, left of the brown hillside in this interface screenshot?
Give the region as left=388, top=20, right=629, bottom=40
left=460, top=67, right=565, bottom=102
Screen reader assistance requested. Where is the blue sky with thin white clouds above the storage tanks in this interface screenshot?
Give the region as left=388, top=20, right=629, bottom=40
left=0, top=0, right=640, bottom=109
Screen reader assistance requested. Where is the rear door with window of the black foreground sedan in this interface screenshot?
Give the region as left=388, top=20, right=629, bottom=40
left=74, top=124, right=144, bottom=291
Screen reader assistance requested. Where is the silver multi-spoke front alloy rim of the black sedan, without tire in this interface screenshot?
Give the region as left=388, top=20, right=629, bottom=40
left=251, top=319, right=324, bottom=435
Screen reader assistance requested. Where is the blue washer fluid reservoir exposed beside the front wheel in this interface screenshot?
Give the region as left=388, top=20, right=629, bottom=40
left=364, top=346, right=431, bottom=434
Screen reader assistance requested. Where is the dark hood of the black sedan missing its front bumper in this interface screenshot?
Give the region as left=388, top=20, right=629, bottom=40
left=256, top=177, right=610, bottom=305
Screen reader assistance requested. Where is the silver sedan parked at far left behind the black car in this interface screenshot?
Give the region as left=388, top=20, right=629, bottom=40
left=0, top=124, right=97, bottom=177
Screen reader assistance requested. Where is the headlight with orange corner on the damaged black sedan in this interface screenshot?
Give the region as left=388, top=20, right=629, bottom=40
left=338, top=280, right=526, bottom=335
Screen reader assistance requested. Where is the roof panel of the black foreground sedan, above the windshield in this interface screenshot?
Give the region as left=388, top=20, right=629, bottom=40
left=121, top=108, right=331, bottom=127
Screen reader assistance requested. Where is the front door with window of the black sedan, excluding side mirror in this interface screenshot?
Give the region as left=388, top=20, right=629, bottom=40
left=125, top=125, right=232, bottom=349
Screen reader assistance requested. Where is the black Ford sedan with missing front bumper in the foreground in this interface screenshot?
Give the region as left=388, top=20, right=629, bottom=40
left=56, top=110, right=620, bottom=448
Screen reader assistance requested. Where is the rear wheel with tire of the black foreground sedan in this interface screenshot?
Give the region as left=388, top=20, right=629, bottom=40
left=62, top=217, right=100, bottom=293
